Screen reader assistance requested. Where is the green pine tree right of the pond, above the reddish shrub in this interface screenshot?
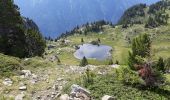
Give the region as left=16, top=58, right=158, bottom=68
left=128, top=34, right=151, bottom=70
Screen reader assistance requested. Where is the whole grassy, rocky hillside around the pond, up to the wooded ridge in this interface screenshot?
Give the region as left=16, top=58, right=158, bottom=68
left=0, top=0, right=170, bottom=100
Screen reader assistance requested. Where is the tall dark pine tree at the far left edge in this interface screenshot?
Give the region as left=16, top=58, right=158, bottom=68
left=0, top=0, right=27, bottom=57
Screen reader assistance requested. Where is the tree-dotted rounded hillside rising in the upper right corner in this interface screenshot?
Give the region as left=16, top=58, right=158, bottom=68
left=118, top=0, right=170, bottom=28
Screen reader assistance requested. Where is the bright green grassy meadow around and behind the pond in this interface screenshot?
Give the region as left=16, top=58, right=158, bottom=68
left=52, top=25, right=170, bottom=65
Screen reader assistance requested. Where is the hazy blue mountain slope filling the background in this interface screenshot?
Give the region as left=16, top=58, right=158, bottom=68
left=14, top=0, right=159, bottom=37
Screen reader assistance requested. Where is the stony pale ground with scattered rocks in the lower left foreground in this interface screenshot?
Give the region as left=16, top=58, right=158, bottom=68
left=0, top=52, right=118, bottom=100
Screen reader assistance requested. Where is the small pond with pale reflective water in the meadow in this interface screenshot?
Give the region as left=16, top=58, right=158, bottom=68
left=74, top=44, right=112, bottom=60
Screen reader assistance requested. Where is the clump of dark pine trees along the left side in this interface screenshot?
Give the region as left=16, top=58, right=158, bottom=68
left=0, top=0, right=46, bottom=58
